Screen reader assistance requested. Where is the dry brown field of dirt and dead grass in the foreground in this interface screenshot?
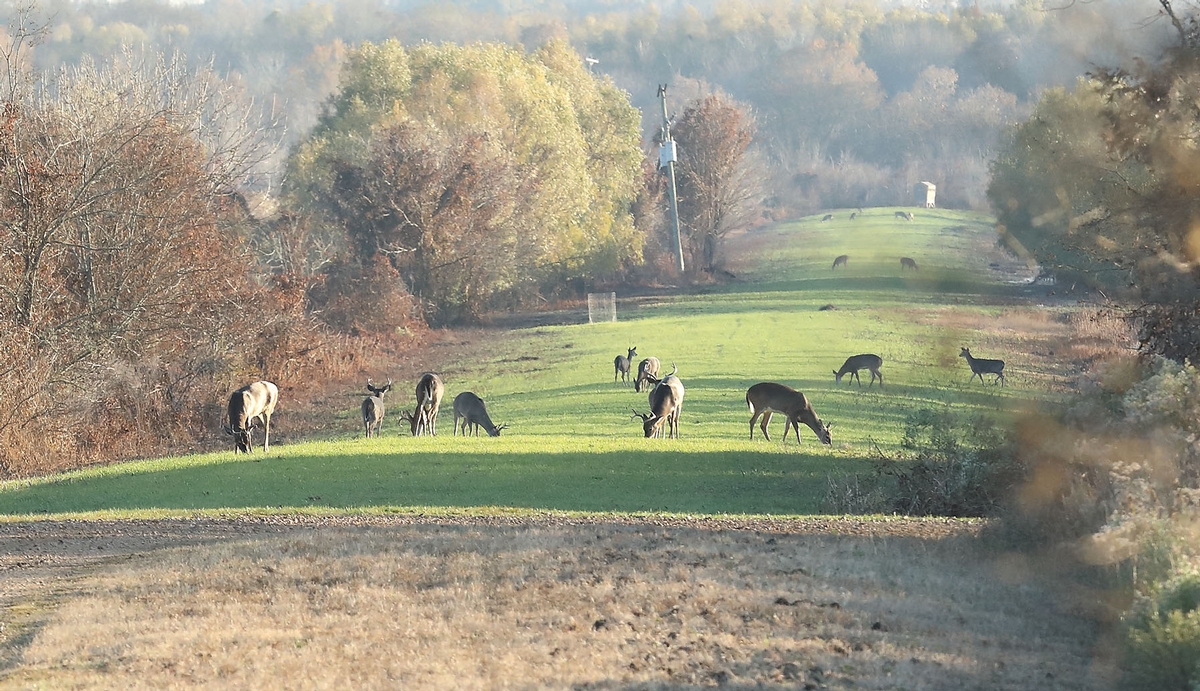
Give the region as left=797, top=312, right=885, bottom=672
left=0, top=515, right=1115, bottom=691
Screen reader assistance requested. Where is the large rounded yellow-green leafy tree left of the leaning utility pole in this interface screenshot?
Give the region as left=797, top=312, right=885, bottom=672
left=289, top=41, right=642, bottom=319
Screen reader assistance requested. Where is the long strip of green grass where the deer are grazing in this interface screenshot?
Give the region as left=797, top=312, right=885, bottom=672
left=0, top=209, right=1049, bottom=517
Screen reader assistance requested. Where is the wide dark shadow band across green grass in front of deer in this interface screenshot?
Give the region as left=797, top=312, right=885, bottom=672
left=0, top=448, right=865, bottom=515
